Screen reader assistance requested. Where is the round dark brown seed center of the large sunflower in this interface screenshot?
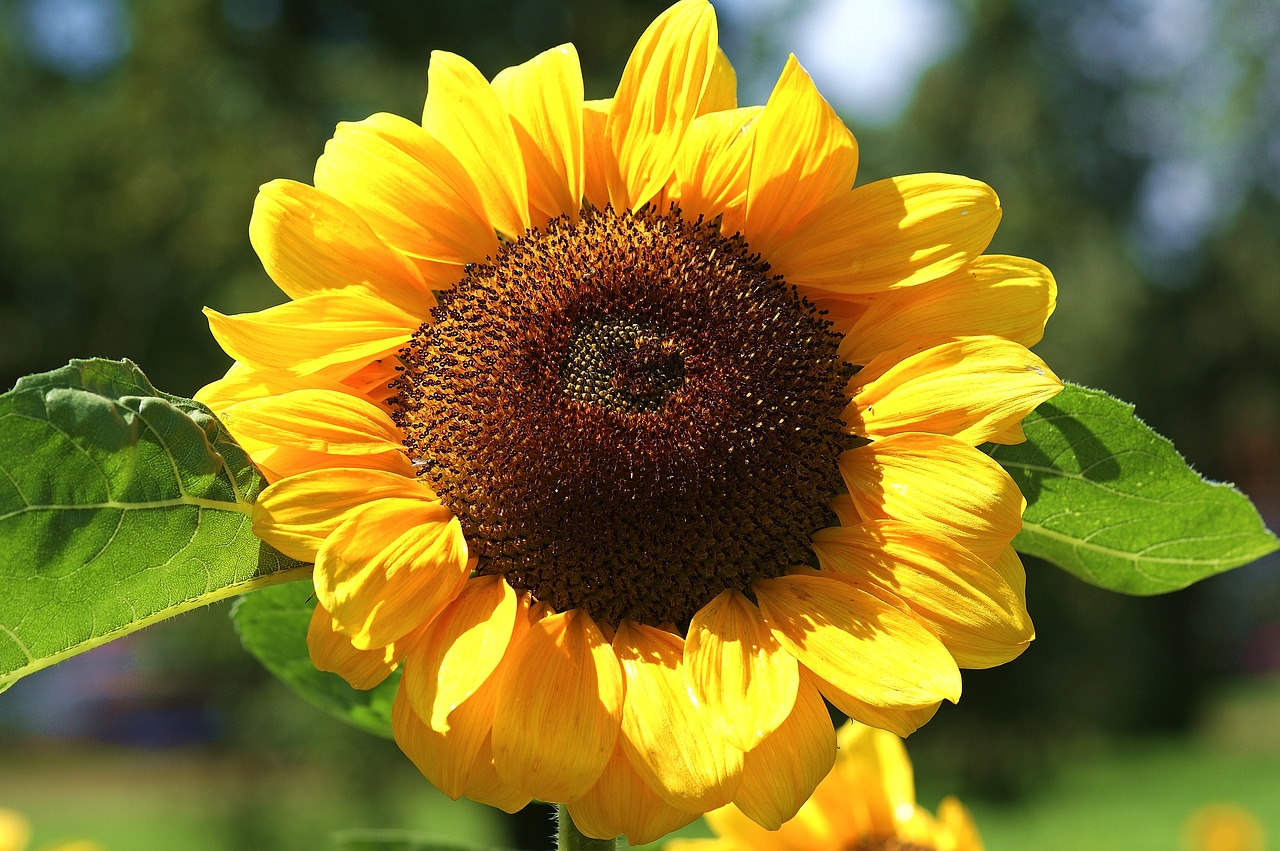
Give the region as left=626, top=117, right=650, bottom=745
left=392, top=209, right=849, bottom=624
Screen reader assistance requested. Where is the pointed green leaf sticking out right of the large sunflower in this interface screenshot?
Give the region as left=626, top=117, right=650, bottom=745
left=987, top=384, right=1280, bottom=594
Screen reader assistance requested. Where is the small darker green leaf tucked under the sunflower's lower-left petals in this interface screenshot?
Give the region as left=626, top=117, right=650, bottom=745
left=232, top=580, right=399, bottom=738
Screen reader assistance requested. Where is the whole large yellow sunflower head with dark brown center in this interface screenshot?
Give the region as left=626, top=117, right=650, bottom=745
left=197, top=0, right=1061, bottom=842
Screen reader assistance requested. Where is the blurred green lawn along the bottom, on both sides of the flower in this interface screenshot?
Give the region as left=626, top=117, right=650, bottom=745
left=0, top=721, right=1280, bottom=851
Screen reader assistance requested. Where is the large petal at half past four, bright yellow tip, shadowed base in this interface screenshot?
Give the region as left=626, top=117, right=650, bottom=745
left=755, top=571, right=960, bottom=708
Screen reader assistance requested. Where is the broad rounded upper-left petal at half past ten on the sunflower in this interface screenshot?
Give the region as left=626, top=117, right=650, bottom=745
left=315, top=113, right=498, bottom=264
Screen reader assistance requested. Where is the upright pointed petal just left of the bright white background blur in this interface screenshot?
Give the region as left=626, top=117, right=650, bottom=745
left=744, top=56, right=858, bottom=255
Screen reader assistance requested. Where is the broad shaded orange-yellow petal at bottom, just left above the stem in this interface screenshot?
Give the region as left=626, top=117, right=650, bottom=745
left=493, top=609, right=623, bottom=801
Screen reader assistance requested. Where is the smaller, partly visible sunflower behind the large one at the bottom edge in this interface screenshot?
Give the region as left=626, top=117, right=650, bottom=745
left=663, top=720, right=983, bottom=851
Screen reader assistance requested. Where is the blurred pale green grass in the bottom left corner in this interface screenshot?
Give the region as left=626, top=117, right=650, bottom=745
left=0, top=740, right=504, bottom=851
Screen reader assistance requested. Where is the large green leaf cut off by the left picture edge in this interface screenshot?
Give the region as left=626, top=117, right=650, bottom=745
left=0, top=360, right=310, bottom=691
